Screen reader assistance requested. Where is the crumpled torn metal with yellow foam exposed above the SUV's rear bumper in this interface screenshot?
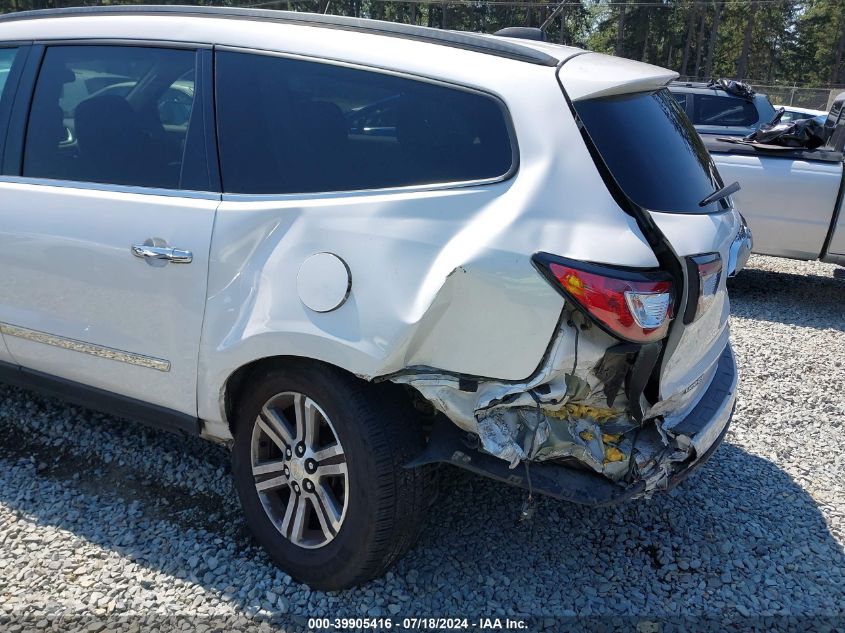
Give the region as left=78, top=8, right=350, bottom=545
left=393, top=328, right=694, bottom=491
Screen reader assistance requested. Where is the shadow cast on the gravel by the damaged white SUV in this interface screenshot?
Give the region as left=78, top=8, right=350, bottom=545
left=0, top=396, right=845, bottom=618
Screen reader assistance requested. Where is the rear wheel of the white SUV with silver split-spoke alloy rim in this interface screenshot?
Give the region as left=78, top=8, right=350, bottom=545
left=232, top=362, right=430, bottom=590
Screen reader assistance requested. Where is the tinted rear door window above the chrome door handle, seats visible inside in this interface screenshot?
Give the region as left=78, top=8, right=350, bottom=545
left=23, top=46, right=195, bottom=189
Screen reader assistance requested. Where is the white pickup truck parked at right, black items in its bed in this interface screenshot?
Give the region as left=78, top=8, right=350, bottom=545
left=702, top=92, right=845, bottom=265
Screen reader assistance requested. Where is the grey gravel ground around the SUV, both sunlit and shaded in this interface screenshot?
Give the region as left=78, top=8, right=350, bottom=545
left=0, top=257, right=845, bottom=631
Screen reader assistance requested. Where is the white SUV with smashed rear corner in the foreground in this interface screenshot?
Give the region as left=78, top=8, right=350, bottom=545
left=0, top=7, right=748, bottom=589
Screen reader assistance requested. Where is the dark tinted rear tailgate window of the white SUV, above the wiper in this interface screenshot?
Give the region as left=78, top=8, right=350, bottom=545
left=575, top=89, right=721, bottom=213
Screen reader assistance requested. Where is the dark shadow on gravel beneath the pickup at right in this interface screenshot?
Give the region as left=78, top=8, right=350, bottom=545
left=728, top=268, right=845, bottom=331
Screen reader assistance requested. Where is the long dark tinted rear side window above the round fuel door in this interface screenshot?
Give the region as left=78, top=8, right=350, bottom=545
left=216, top=52, right=513, bottom=193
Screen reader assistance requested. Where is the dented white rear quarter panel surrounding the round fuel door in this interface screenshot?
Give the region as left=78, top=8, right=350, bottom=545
left=198, top=64, right=656, bottom=439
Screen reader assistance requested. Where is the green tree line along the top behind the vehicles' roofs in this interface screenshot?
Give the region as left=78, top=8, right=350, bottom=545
left=0, top=0, right=845, bottom=86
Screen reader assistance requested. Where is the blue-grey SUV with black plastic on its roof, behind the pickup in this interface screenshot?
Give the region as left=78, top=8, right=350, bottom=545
left=669, top=81, right=775, bottom=136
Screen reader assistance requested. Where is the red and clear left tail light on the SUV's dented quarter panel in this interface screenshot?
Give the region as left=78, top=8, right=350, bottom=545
left=534, top=255, right=673, bottom=343
